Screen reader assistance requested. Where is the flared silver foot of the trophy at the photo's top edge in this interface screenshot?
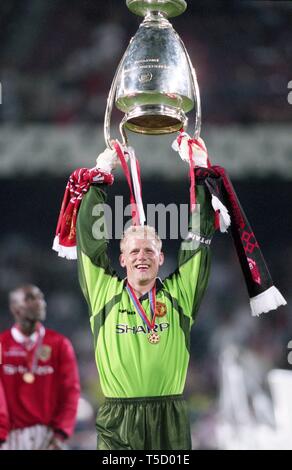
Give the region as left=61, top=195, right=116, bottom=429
left=127, top=0, right=187, bottom=18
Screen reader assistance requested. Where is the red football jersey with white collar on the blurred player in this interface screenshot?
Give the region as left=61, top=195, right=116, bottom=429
left=0, top=325, right=80, bottom=440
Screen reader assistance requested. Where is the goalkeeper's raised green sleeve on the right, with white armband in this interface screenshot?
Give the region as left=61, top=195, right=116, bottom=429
left=164, top=183, right=214, bottom=320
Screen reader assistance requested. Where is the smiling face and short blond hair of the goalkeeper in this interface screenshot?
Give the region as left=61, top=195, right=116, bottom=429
left=120, top=235, right=164, bottom=286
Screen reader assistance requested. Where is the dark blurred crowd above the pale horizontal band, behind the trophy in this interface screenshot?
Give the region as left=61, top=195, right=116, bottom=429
left=0, top=0, right=292, bottom=125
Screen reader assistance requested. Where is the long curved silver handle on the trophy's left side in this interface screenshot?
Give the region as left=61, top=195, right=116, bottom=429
left=103, top=46, right=132, bottom=149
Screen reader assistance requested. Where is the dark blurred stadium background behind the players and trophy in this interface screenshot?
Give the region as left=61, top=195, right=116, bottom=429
left=0, top=0, right=292, bottom=449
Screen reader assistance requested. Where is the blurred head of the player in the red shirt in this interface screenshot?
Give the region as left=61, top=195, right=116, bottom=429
left=10, top=286, right=47, bottom=324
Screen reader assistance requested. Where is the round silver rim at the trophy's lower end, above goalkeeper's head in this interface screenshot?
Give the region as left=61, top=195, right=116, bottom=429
left=122, top=105, right=187, bottom=135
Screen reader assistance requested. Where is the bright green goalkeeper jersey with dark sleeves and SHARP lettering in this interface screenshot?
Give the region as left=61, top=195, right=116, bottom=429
left=77, top=185, right=214, bottom=398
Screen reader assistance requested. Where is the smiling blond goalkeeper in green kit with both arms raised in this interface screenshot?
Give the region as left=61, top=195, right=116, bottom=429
left=77, top=141, right=214, bottom=450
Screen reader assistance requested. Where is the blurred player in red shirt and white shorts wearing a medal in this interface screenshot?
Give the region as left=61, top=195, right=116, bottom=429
left=0, top=285, right=80, bottom=450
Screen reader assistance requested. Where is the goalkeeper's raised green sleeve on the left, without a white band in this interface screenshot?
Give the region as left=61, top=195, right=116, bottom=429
left=77, top=185, right=121, bottom=315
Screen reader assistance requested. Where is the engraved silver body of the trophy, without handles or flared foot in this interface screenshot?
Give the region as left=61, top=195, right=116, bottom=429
left=115, top=12, right=194, bottom=135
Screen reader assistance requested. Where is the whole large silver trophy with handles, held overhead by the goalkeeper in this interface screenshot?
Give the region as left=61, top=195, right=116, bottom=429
left=104, top=0, right=201, bottom=147
